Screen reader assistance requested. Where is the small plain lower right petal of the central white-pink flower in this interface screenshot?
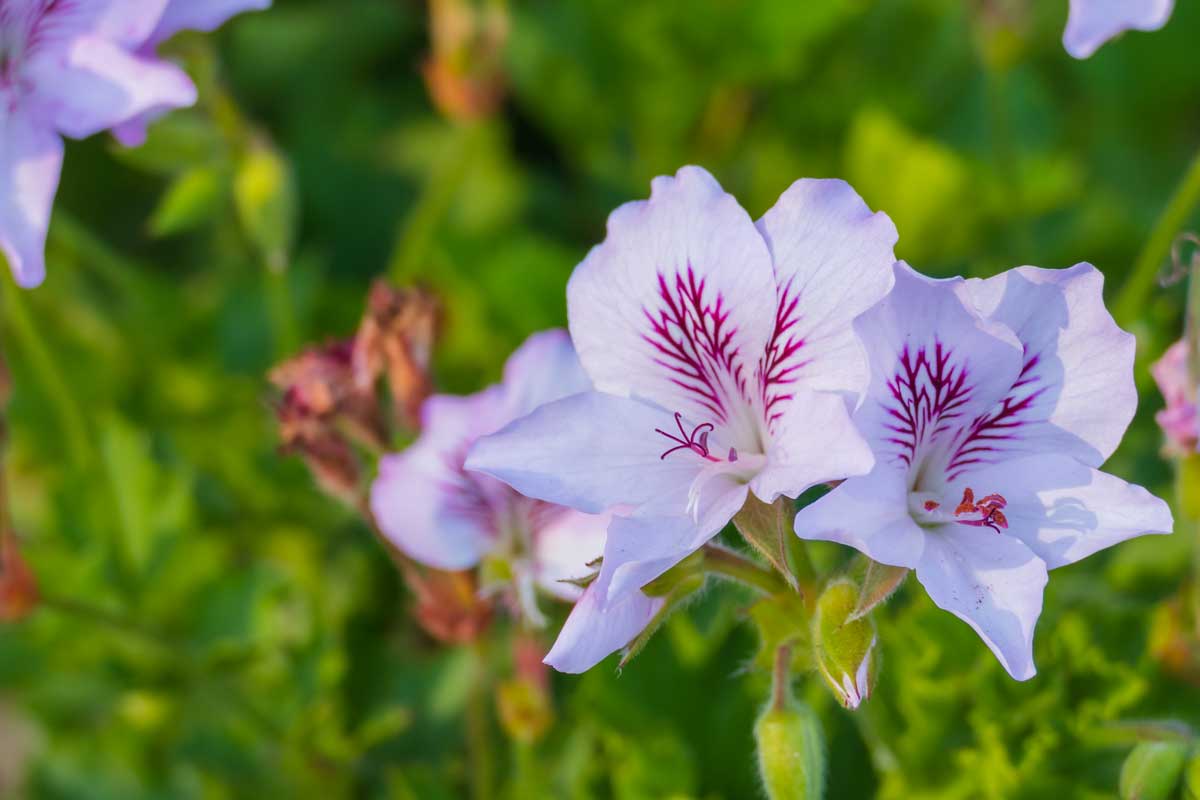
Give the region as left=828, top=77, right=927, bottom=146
left=750, top=391, right=875, bottom=503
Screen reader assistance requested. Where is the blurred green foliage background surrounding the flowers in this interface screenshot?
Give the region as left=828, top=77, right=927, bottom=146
left=0, top=0, right=1200, bottom=800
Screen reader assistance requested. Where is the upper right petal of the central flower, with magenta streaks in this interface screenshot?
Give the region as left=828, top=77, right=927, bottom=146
left=757, top=179, right=896, bottom=410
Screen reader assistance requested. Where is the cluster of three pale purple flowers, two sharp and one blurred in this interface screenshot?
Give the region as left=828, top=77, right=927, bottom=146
left=371, top=167, right=1172, bottom=680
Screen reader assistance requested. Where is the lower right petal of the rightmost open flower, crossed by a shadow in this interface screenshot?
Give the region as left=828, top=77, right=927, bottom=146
left=952, top=455, right=1174, bottom=570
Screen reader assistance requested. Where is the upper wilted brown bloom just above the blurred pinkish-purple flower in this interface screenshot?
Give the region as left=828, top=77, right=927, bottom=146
left=353, top=281, right=438, bottom=431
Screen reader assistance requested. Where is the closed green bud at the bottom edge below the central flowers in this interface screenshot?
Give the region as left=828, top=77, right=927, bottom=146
left=754, top=697, right=824, bottom=800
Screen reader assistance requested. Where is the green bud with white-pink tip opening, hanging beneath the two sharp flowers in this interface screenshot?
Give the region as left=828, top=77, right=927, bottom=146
left=812, top=581, right=875, bottom=709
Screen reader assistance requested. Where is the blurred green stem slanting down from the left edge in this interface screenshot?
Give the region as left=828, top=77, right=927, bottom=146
left=0, top=277, right=95, bottom=467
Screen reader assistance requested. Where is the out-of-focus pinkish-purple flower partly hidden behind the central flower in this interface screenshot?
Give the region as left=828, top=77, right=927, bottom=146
left=371, top=331, right=608, bottom=624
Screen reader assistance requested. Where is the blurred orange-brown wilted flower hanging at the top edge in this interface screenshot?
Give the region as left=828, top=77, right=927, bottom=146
left=422, top=0, right=509, bottom=121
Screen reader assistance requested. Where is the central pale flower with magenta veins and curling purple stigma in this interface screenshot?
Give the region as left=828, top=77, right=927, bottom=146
left=467, top=167, right=896, bottom=672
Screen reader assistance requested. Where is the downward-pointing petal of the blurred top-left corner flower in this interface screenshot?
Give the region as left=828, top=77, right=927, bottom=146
left=0, top=110, right=62, bottom=288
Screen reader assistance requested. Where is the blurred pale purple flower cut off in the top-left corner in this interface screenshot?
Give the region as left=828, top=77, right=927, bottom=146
left=0, top=0, right=265, bottom=287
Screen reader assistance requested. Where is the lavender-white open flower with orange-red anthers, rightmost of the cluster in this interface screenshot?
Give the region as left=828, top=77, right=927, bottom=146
left=796, top=264, right=1172, bottom=680
